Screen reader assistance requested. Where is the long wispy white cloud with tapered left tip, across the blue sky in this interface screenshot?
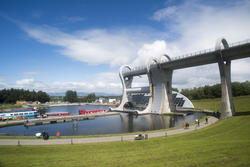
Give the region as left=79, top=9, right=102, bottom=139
left=22, top=24, right=158, bottom=66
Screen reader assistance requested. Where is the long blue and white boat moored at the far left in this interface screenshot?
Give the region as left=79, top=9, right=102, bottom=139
left=0, top=108, right=39, bottom=121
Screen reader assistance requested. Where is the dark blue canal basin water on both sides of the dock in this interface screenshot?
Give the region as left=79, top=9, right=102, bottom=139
left=0, top=105, right=205, bottom=136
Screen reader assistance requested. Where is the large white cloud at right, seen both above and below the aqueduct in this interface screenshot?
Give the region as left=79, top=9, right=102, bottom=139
left=150, top=1, right=250, bottom=88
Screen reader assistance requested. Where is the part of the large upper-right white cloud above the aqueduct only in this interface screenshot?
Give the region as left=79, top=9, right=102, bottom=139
left=153, top=1, right=250, bottom=54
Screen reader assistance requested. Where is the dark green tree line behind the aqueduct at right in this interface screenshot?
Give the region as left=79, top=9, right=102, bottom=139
left=180, top=81, right=250, bottom=100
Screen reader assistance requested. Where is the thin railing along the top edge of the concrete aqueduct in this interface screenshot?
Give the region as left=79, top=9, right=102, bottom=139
left=123, top=39, right=250, bottom=75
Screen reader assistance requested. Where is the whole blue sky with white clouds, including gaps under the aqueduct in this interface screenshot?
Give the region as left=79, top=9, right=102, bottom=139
left=0, top=0, right=250, bottom=95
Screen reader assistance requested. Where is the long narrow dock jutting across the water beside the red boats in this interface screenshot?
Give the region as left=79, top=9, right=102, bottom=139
left=0, top=112, right=119, bottom=127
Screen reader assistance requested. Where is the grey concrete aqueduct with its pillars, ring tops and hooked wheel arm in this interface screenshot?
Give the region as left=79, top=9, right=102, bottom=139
left=112, top=38, right=250, bottom=119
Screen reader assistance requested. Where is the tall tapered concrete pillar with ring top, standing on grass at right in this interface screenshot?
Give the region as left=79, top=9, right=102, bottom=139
left=215, top=38, right=235, bottom=119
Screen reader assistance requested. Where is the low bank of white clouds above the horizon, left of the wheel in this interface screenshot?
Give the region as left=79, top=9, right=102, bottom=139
left=0, top=72, right=122, bottom=95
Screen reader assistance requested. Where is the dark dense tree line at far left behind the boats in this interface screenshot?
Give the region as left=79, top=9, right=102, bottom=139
left=0, top=88, right=50, bottom=104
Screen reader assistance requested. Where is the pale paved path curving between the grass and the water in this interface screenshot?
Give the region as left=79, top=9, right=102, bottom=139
left=0, top=117, right=218, bottom=145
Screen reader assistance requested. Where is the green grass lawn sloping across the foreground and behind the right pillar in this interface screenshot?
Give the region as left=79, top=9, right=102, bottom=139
left=0, top=96, right=250, bottom=167
